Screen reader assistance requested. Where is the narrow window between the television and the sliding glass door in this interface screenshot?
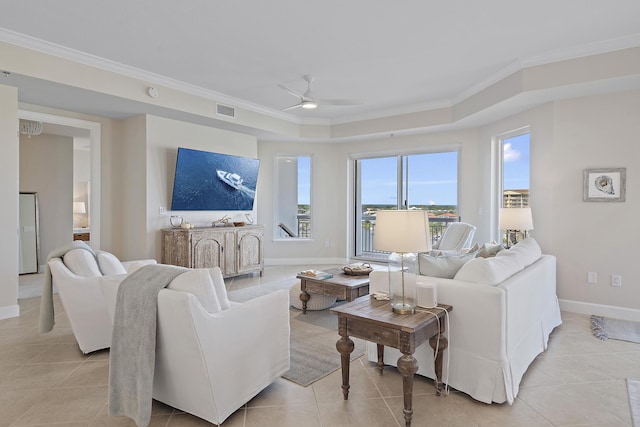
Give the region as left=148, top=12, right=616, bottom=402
left=274, top=156, right=312, bottom=239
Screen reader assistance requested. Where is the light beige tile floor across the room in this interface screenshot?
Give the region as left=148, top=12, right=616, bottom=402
left=7, top=266, right=640, bottom=427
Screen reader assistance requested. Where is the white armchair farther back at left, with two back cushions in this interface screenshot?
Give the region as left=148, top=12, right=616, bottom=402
left=47, top=248, right=156, bottom=354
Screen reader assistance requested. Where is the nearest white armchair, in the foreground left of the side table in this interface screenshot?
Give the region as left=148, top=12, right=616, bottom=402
left=102, top=267, right=290, bottom=424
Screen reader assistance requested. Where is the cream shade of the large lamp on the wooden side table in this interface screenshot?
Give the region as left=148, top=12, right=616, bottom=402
left=373, top=210, right=431, bottom=253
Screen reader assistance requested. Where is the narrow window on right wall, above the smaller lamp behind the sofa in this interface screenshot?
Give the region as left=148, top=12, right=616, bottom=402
left=500, top=129, right=530, bottom=243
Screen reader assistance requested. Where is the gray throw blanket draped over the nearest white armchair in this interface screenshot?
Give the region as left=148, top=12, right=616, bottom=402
left=109, top=264, right=188, bottom=427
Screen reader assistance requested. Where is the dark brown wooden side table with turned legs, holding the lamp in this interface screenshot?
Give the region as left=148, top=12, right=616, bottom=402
left=331, top=296, right=453, bottom=427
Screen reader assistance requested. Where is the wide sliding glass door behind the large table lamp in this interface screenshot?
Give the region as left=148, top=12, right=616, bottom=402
left=354, top=151, right=458, bottom=260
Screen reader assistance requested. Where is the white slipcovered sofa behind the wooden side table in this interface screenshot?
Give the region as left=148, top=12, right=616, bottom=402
left=367, top=238, right=562, bottom=403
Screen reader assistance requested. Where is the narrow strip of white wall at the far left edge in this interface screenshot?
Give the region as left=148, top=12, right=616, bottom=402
left=0, top=85, right=20, bottom=319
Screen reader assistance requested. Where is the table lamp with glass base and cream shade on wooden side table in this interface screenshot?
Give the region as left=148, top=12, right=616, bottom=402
left=373, top=210, right=431, bottom=314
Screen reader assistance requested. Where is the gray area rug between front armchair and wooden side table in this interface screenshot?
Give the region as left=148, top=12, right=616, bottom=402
left=229, top=280, right=365, bottom=387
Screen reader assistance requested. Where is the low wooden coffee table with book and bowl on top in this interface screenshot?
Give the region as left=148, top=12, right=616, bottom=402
left=296, top=268, right=369, bottom=314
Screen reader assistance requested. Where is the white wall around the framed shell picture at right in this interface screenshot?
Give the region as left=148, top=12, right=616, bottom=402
left=547, top=91, right=640, bottom=316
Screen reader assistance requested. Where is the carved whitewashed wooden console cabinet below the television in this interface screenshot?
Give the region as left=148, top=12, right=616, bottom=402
left=161, top=225, right=264, bottom=277
